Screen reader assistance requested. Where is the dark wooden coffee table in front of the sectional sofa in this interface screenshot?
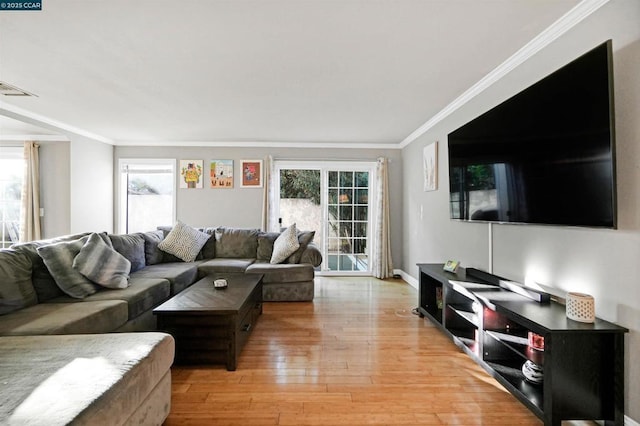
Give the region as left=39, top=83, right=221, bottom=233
left=153, top=274, right=262, bottom=371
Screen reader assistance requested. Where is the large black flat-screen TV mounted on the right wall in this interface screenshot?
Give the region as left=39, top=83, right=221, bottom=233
left=448, top=40, right=616, bottom=228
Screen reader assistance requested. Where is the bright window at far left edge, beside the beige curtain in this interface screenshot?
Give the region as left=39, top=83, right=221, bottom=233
left=0, top=147, right=24, bottom=248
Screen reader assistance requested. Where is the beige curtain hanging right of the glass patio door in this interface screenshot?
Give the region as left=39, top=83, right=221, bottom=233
left=371, top=157, right=393, bottom=279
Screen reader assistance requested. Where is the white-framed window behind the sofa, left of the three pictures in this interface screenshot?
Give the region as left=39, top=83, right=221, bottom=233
left=118, top=159, right=176, bottom=233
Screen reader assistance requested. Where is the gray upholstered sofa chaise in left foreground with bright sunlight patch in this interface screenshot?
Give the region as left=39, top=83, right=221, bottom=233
left=0, top=333, right=174, bottom=426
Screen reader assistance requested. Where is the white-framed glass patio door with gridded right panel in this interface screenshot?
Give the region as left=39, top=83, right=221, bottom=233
left=273, top=161, right=375, bottom=275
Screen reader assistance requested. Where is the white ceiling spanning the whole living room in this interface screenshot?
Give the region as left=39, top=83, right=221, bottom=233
left=0, top=0, right=590, bottom=147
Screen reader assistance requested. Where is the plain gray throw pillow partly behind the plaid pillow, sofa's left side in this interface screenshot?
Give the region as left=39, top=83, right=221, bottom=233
left=38, top=236, right=98, bottom=299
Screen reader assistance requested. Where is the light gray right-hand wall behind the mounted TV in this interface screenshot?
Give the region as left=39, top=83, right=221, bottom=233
left=402, top=0, right=640, bottom=421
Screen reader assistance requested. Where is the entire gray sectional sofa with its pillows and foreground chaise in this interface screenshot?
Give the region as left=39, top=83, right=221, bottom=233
left=0, top=224, right=322, bottom=424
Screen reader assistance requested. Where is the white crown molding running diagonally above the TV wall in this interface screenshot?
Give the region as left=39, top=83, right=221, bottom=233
left=399, top=0, right=609, bottom=148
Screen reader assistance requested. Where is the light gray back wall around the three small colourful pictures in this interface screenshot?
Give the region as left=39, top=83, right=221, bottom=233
left=114, top=146, right=402, bottom=265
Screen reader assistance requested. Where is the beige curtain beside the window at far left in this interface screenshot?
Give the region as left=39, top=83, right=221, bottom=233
left=20, top=142, right=42, bottom=241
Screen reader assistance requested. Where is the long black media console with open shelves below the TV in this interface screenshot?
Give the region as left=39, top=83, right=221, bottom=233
left=418, top=263, right=628, bottom=426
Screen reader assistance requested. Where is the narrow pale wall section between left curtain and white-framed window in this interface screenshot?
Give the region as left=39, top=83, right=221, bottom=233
left=69, top=135, right=114, bottom=233
